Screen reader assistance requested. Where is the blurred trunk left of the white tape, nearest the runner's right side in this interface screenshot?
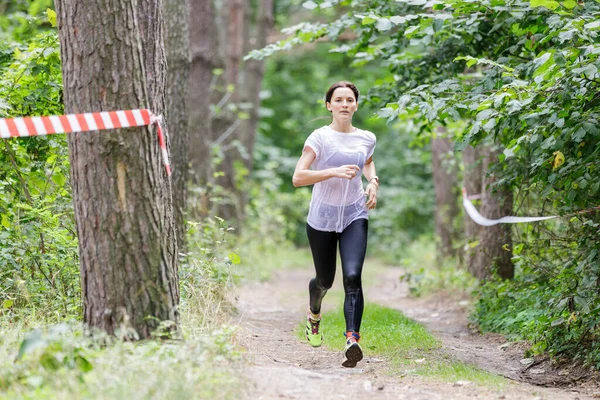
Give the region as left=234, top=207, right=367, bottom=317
left=431, top=129, right=458, bottom=262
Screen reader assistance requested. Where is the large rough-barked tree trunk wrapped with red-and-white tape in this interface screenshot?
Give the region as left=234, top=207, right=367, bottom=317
left=56, top=0, right=179, bottom=338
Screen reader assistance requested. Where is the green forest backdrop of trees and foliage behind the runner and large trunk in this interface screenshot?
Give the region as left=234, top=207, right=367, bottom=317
left=0, top=0, right=600, bottom=396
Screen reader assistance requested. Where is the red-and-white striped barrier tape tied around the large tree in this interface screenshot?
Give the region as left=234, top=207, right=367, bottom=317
left=0, top=109, right=171, bottom=176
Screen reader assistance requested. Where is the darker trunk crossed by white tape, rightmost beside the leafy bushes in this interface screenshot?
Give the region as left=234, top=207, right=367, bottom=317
left=471, top=147, right=514, bottom=279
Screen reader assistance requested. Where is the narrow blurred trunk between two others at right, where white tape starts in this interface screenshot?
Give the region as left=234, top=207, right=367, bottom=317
left=463, top=146, right=483, bottom=273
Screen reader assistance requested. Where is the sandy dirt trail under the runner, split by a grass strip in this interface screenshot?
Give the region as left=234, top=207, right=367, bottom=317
left=236, top=267, right=596, bottom=400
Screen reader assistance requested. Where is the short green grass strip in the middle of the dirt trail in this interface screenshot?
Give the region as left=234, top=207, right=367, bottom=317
left=297, top=303, right=506, bottom=388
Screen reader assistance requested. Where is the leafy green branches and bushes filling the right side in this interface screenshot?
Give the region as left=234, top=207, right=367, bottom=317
left=252, top=0, right=600, bottom=367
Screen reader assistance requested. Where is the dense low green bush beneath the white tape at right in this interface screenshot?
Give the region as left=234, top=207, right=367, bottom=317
left=472, top=214, right=600, bottom=368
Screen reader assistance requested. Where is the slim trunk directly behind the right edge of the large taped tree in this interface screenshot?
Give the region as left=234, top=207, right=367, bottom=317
left=165, top=0, right=190, bottom=251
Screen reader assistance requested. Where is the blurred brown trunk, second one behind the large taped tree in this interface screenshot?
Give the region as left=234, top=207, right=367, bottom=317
left=188, top=0, right=222, bottom=188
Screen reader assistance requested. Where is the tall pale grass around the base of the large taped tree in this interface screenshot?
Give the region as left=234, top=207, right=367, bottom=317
left=0, top=219, right=244, bottom=399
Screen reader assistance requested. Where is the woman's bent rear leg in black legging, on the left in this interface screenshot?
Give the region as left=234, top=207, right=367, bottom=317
left=306, top=224, right=337, bottom=315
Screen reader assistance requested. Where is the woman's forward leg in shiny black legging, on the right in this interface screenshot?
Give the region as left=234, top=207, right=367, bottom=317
left=340, top=218, right=369, bottom=333
